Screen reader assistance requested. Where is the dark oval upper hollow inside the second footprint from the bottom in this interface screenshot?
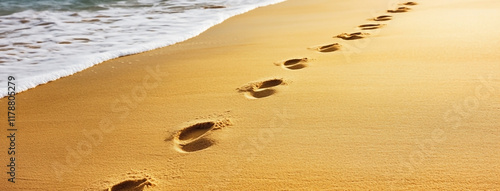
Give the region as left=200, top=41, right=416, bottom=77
left=176, top=121, right=215, bottom=145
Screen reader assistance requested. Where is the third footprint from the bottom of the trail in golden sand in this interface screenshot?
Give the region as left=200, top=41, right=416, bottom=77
left=237, top=78, right=285, bottom=99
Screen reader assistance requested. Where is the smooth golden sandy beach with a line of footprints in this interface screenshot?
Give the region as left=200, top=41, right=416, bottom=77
left=0, top=0, right=500, bottom=191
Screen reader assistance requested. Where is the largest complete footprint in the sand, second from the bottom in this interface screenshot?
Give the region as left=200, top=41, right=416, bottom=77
left=166, top=119, right=231, bottom=153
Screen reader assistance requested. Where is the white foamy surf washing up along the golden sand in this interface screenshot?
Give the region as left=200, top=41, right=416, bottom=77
left=0, top=0, right=285, bottom=97
